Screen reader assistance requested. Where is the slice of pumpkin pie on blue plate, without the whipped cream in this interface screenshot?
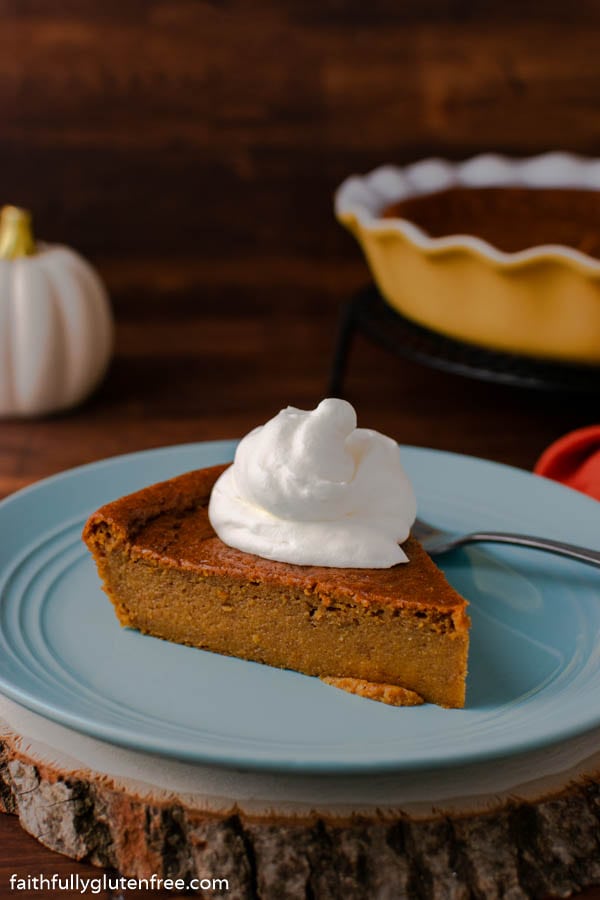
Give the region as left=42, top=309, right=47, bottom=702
left=83, top=466, right=470, bottom=707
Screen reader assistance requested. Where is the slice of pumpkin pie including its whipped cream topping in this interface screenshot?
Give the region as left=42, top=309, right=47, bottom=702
left=83, top=401, right=469, bottom=707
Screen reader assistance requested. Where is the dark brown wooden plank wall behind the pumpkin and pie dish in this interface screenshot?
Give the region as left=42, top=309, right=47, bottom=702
left=0, top=0, right=600, bottom=271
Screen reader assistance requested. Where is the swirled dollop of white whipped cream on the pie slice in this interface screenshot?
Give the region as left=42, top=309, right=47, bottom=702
left=208, top=399, right=416, bottom=568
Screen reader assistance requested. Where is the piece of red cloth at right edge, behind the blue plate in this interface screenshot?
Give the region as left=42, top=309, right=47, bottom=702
left=533, top=425, right=600, bottom=500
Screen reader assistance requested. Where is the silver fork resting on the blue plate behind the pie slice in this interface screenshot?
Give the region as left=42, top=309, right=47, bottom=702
left=412, top=519, right=600, bottom=567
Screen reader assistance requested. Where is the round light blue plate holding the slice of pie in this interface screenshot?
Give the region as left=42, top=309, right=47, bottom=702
left=0, top=441, right=600, bottom=772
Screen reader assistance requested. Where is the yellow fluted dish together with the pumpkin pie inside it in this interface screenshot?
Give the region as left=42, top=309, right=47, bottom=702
left=335, top=153, right=600, bottom=366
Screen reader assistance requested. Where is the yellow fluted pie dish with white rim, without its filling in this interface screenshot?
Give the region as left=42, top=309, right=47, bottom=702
left=335, top=153, right=600, bottom=365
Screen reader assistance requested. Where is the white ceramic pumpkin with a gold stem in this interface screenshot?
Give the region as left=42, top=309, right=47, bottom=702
left=0, top=206, right=113, bottom=416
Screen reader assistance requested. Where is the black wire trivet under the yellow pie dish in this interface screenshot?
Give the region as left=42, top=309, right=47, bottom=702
left=329, top=285, right=600, bottom=397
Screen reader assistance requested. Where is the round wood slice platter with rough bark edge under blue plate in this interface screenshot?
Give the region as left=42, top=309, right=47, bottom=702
left=0, top=696, right=600, bottom=900
